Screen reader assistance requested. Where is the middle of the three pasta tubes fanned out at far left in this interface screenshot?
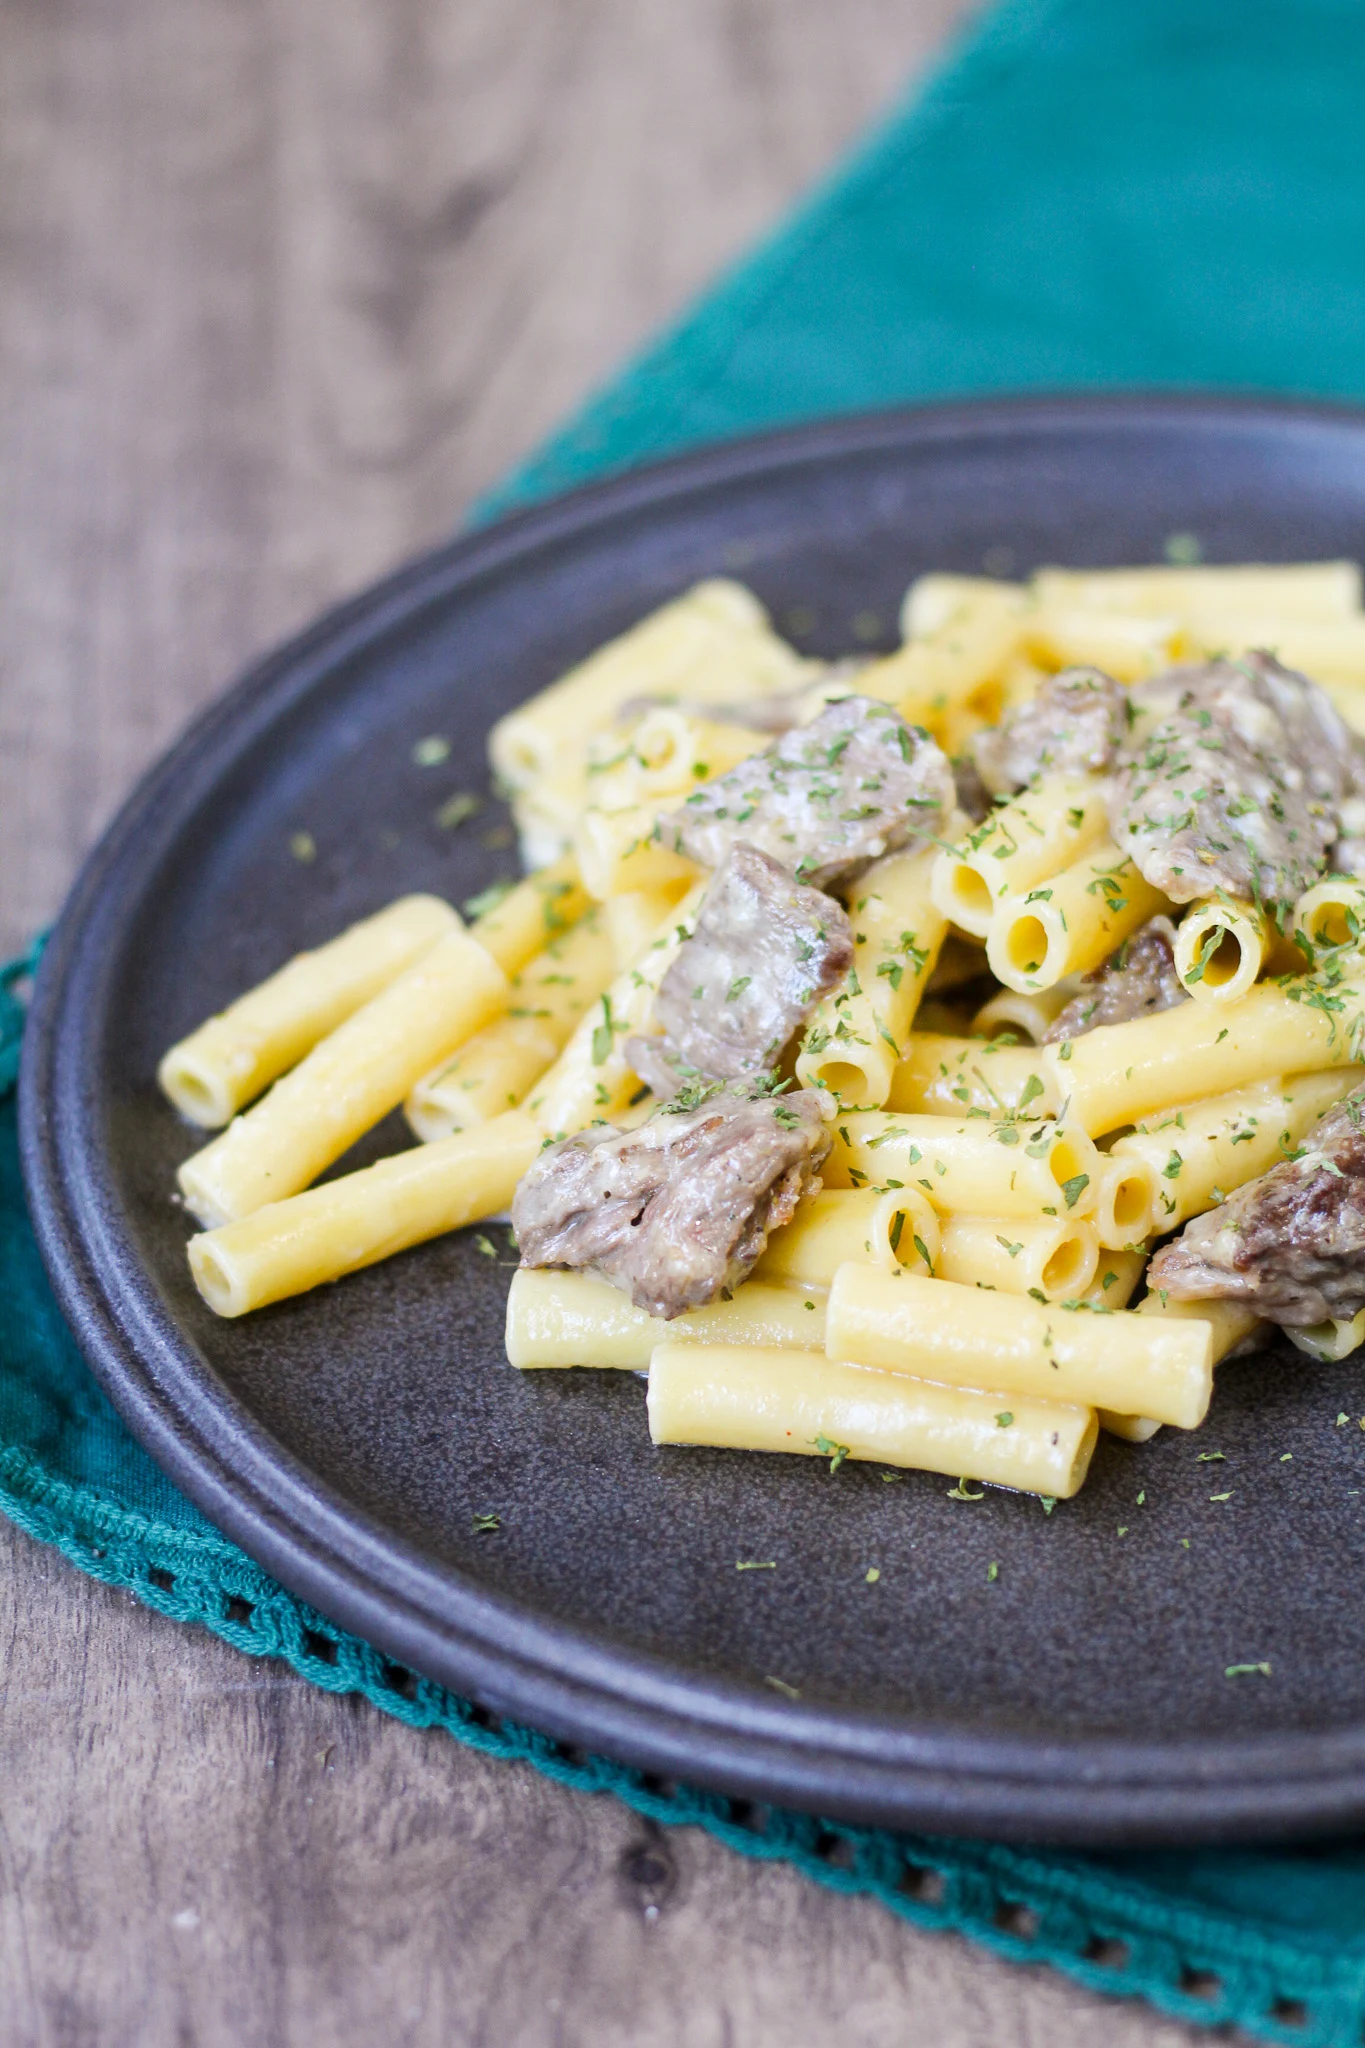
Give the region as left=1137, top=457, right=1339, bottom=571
left=178, top=932, right=508, bottom=1227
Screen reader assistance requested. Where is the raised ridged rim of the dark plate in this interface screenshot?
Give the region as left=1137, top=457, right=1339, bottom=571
left=18, top=391, right=1365, bottom=1845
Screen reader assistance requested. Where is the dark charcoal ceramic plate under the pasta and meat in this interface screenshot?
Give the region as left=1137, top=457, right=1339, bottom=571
left=23, top=399, right=1365, bottom=1841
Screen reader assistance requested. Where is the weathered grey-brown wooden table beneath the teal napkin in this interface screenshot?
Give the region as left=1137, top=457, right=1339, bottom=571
left=0, top=0, right=1195, bottom=2048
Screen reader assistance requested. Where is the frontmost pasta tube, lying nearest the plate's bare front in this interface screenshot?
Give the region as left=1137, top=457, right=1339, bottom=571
left=649, top=1343, right=1095, bottom=1499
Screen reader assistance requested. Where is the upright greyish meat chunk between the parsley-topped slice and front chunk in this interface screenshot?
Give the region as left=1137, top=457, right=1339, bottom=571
left=624, top=840, right=853, bottom=1100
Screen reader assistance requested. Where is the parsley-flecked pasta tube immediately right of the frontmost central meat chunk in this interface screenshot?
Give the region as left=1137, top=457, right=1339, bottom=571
left=823, top=1110, right=1099, bottom=1223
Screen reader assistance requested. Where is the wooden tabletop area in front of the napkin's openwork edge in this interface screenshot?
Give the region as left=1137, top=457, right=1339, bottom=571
left=0, top=1532, right=1195, bottom=2048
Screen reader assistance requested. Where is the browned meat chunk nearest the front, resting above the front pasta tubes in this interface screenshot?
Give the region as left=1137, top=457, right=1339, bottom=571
left=512, top=1085, right=831, bottom=1319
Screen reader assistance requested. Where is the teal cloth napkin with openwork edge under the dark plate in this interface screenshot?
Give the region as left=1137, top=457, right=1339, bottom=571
left=0, top=0, right=1365, bottom=2048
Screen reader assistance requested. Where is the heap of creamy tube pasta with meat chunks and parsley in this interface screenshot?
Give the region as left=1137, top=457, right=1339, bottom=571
left=162, top=563, right=1365, bottom=1523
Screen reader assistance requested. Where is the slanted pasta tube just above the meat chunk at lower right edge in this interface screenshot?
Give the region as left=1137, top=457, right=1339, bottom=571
left=1109, top=1067, right=1365, bottom=1233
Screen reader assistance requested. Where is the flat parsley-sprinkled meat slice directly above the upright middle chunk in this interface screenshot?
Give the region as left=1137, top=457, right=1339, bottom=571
left=655, top=696, right=954, bottom=889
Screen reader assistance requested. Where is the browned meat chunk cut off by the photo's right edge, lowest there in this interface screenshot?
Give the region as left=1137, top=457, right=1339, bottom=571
left=1148, top=1087, right=1365, bottom=1327
